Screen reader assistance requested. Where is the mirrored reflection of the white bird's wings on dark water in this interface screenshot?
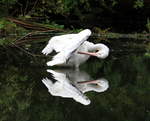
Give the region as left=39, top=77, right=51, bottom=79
left=42, top=77, right=90, bottom=105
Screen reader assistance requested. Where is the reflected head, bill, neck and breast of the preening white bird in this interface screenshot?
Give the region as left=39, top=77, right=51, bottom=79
left=62, top=69, right=109, bottom=93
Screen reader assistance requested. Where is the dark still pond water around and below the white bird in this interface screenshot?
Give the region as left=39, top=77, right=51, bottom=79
left=0, top=43, right=150, bottom=121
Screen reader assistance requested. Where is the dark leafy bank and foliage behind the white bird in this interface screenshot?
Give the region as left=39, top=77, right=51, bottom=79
left=0, top=0, right=150, bottom=45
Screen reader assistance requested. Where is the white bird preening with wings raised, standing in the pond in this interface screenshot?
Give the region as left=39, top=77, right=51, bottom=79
left=42, top=29, right=109, bottom=68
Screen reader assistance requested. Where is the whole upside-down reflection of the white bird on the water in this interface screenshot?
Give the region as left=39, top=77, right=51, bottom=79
left=42, top=69, right=109, bottom=105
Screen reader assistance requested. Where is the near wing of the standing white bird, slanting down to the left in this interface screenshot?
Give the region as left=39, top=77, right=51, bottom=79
left=47, top=36, right=87, bottom=66
